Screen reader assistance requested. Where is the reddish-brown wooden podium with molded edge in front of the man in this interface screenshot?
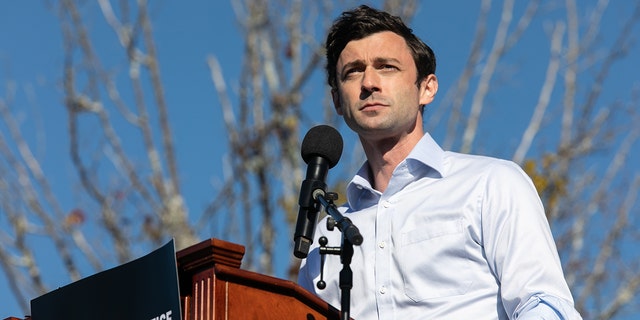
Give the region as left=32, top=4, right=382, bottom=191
left=172, top=239, right=340, bottom=320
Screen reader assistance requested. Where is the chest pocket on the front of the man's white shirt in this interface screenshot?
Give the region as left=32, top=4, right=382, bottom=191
left=398, top=218, right=473, bottom=302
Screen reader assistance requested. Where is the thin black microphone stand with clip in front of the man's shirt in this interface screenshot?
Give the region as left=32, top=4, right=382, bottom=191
left=313, top=189, right=363, bottom=320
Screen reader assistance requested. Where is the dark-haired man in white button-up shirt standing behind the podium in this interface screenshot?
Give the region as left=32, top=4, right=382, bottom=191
left=299, top=6, right=580, bottom=319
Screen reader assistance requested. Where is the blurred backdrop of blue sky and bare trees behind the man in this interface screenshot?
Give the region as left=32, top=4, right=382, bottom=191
left=0, top=0, right=640, bottom=319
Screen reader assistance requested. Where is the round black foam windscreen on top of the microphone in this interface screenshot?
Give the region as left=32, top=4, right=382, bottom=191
left=300, top=125, right=342, bottom=168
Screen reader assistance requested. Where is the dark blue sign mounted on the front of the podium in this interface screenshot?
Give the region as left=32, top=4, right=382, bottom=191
left=31, top=240, right=182, bottom=320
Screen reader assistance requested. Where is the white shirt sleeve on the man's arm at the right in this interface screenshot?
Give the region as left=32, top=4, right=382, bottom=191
left=481, top=161, right=580, bottom=319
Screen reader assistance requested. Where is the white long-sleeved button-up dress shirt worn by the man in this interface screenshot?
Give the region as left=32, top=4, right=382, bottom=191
left=298, top=134, right=580, bottom=320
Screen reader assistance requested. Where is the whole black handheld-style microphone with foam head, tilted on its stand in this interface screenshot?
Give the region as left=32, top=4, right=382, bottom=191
left=293, top=125, right=342, bottom=259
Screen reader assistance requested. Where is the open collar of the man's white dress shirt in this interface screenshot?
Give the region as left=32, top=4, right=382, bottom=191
left=347, top=133, right=445, bottom=209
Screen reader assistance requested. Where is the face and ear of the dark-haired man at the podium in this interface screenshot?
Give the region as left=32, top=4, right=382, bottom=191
left=332, top=31, right=437, bottom=140
